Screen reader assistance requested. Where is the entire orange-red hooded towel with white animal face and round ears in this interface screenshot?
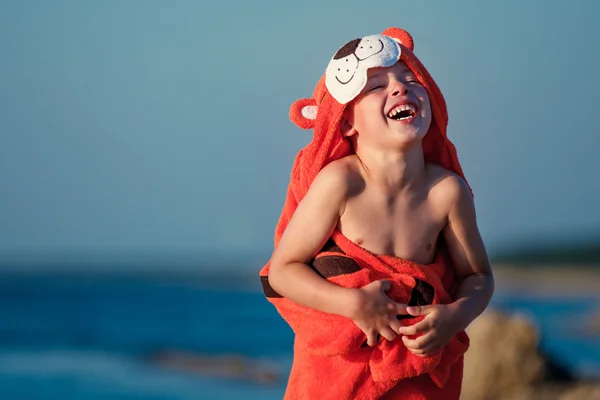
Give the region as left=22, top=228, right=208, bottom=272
left=260, top=28, right=469, bottom=400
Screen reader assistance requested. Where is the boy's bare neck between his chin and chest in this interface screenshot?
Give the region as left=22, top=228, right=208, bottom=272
left=356, top=143, right=425, bottom=192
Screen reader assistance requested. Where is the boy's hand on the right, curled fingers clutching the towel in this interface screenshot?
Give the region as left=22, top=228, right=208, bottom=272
left=398, top=304, right=461, bottom=357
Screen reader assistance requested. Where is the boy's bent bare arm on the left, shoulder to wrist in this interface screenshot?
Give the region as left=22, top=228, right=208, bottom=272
left=269, top=163, right=355, bottom=317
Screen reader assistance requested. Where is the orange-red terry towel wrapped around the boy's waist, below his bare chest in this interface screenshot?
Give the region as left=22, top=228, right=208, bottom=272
left=263, top=231, right=469, bottom=400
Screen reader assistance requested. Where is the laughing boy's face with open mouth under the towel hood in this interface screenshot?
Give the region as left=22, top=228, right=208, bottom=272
left=344, top=61, right=431, bottom=146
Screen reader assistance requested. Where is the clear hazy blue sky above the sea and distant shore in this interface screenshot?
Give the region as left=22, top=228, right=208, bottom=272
left=0, top=0, right=600, bottom=266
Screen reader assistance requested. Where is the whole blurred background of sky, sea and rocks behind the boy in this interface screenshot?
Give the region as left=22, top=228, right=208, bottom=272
left=0, top=0, right=600, bottom=400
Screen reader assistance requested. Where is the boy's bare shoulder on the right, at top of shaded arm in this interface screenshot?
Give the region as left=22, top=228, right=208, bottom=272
left=426, top=164, right=472, bottom=208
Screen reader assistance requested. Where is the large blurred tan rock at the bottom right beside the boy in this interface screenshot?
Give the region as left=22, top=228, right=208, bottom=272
left=461, top=310, right=600, bottom=400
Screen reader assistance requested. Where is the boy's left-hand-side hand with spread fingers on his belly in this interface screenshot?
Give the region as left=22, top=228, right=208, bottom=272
left=351, top=280, right=407, bottom=347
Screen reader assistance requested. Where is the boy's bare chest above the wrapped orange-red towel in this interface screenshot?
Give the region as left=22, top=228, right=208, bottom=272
left=338, top=193, right=446, bottom=264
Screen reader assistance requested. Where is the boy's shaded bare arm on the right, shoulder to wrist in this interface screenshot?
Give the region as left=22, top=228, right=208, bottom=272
left=444, top=177, right=494, bottom=329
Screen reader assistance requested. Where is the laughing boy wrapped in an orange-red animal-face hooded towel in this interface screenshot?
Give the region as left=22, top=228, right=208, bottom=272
left=261, top=28, right=494, bottom=399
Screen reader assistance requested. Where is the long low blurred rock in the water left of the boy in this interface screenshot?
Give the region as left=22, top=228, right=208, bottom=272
left=150, top=350, right=280, bottom=384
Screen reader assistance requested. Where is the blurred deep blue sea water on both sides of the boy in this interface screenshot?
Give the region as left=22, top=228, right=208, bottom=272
left=0, top=274, right=600, bottom=400
